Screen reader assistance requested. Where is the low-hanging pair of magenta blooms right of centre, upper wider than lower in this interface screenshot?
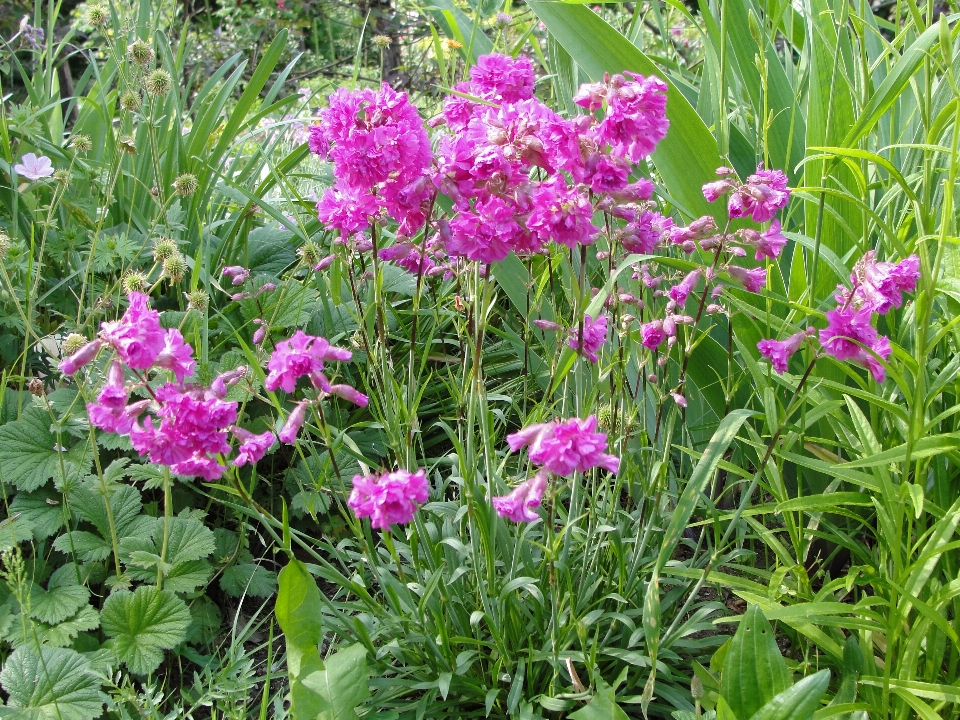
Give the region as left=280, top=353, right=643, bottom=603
left=492, top=415, right=620, bottom=522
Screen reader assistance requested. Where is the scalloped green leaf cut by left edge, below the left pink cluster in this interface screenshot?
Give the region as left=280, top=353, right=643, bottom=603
left=0, top=407, right=68, bottom=492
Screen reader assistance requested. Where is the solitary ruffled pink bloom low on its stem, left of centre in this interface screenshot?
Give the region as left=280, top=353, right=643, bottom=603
left=347, top=469, right=429, bottom=528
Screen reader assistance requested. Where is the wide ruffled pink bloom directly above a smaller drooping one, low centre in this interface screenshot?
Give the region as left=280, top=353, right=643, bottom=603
left=530, top=415, right=620, bottom=475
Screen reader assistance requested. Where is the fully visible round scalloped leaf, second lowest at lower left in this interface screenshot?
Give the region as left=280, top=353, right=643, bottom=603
left=101, top=585, right=190, bottom=675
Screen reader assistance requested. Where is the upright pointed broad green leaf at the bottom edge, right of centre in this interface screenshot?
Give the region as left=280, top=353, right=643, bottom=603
left=720, top=605, right=792, bottom=718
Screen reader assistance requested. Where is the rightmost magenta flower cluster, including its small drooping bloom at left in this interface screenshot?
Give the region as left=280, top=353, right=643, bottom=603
left=757, top=250, right=920, bottom=382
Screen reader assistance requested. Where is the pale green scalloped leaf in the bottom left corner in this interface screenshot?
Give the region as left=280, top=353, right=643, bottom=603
left=0, top=645, right=106, bottom=720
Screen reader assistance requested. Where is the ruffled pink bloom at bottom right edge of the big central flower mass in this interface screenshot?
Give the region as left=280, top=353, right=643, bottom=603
left=527, top=177, right=599, bottom=248
